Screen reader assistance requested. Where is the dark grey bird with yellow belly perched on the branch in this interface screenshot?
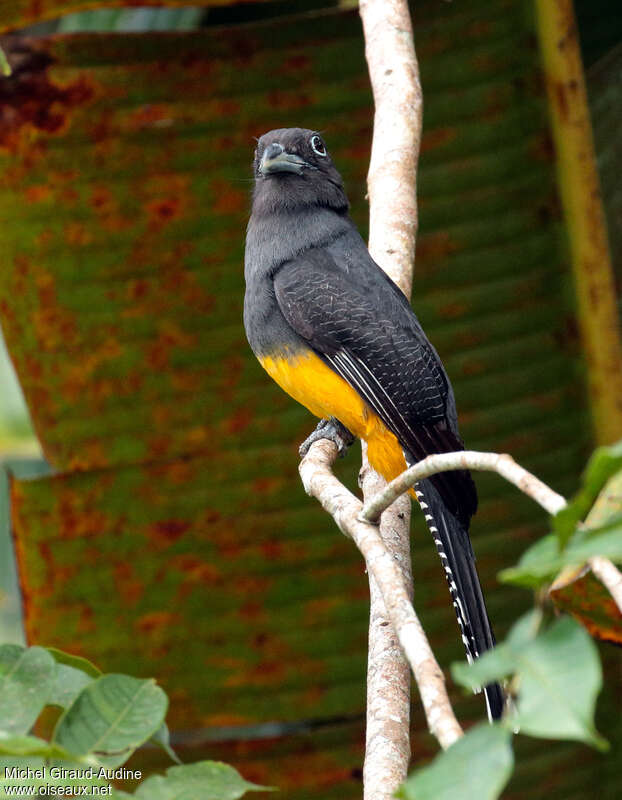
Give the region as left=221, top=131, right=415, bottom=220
left=244, top=128, right=504, bottom=719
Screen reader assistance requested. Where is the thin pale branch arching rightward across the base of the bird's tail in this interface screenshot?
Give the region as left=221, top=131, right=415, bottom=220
left=361, top=450, right=566, bottom=522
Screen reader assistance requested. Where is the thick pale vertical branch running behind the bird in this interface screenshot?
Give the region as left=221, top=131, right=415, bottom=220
left=359, top=0, right=422, bottom=800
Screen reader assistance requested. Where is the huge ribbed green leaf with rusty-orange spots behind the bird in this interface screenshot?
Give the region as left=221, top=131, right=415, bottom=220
left=0, top=0, right=619, bottom=800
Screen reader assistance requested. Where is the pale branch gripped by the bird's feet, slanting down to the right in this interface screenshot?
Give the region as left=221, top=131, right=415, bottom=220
left=299, top=439, right=462, bottom=748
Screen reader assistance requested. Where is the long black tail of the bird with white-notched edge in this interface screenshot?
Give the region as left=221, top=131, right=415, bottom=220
left=414, top=480, right=504, bottom=720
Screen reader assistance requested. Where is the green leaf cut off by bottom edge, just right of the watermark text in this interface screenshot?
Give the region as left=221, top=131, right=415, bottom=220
left=134, top=761, right=273, bottom=800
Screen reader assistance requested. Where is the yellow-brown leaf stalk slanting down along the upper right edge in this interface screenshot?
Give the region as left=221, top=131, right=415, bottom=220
left=535, top=0, right=622, bottom=444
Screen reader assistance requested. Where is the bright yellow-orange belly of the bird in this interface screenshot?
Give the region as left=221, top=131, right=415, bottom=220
left=259, top=352, right=406, bottom=480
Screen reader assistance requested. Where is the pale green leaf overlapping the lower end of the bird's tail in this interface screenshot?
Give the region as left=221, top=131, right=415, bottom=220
left=452, top=614, right=608, bottom=750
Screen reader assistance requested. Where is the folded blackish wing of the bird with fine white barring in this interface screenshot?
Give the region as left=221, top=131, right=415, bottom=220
left=274, top=248, right=477, bottom=522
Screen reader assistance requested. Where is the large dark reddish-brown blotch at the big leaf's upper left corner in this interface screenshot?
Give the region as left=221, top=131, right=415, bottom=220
left=0, top=39, right=94, bottom=152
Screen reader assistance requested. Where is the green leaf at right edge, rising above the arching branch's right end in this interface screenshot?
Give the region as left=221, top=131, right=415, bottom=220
left=553, top=440, right=622, bottom=548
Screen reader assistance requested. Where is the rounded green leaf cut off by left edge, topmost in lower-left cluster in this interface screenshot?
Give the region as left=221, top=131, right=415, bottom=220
left=0, top=644, right=55, bottom=733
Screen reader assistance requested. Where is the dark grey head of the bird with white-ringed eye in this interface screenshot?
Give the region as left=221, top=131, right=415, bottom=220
left=253, top=128, right=348, bottom=213
